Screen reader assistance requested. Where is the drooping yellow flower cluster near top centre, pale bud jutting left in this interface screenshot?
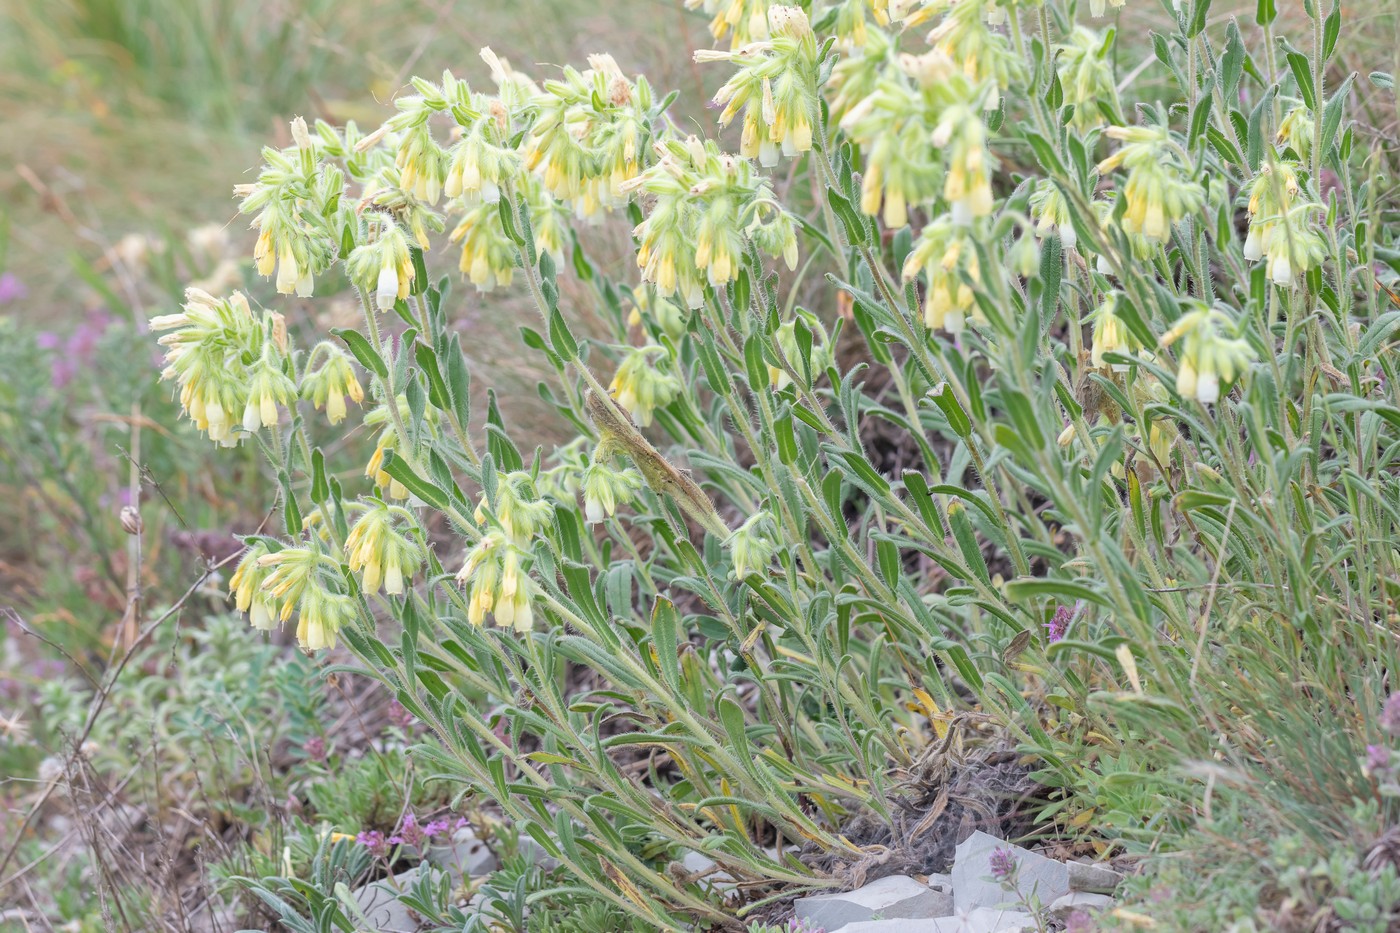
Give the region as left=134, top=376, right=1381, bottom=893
left=694, top=6, right=818, bottom=165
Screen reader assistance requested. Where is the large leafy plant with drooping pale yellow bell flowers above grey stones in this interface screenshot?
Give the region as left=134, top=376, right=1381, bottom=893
left=153, top=0, right=1400, bottom=929
